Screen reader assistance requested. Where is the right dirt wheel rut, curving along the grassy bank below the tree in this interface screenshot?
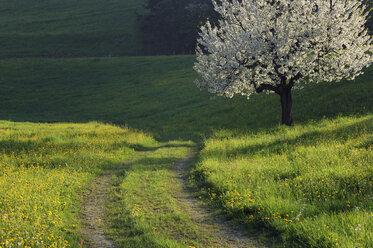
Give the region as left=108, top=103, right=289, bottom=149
left=175, top=148, right=264, bottom=248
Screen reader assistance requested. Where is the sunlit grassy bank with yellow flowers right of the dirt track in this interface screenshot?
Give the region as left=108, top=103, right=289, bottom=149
left=194, top=114, right=373, bottom=248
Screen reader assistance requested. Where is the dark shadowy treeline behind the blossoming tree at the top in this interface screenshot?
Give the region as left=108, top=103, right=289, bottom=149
left=138, top=0, right=373, bottom=55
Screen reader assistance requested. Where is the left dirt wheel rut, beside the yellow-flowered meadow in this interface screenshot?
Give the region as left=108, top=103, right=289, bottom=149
left=82, top=174, right=114, bottom=248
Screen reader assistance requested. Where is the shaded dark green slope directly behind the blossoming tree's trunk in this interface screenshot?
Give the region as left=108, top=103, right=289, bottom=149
left=0, top=56, right=373, bottom=139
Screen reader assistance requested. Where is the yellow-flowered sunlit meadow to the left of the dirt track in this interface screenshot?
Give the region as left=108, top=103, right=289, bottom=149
left=0, top=121, right=154, bottom=248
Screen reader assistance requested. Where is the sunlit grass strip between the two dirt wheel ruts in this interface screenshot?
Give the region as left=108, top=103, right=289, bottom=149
left=109, top=142, right=201, bottom=248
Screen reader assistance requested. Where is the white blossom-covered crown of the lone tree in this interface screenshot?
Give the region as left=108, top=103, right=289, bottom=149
left=194, top=0, right=373, bottom=97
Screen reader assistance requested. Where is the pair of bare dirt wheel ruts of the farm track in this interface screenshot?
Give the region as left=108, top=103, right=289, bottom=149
left=82, top=146, right=263, bottom=248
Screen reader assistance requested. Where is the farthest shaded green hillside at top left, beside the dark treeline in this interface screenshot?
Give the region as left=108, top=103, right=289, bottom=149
left=0, top=0, right=145, bottom=58
